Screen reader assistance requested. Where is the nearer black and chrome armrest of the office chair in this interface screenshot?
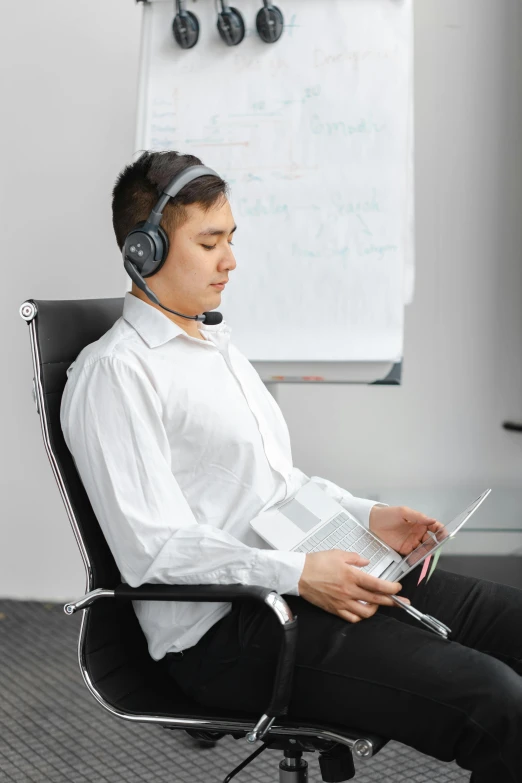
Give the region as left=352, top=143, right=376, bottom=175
left=64, top=584, right=297, bottom=742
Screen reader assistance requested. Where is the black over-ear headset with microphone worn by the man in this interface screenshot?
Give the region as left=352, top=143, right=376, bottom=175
left=122, top=166, right=223, bottom=324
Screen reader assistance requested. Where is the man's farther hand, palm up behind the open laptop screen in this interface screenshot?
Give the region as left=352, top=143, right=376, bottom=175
left=369, top=506, right=446, bottom=555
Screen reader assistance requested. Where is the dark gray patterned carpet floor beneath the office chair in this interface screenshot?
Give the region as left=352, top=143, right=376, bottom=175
left=0, top=600, right=469, bottom=783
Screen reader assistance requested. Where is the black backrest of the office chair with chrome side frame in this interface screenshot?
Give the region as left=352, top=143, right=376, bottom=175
left=20, top=298, right=187, bottom=714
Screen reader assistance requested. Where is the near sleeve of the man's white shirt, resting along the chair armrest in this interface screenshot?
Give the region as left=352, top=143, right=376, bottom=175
left=60, top=357, right=305, bottom=595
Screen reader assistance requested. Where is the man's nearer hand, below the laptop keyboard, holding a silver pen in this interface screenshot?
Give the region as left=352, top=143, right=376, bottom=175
left=298, top=549, right=410, bottom=623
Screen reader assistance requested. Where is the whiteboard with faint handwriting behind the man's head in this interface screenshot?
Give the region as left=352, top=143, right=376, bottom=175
left=136, top=0, right=413, bottom=377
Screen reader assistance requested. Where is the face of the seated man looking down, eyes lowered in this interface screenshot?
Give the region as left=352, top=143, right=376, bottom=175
left=155, top=199, right=236, bottom=315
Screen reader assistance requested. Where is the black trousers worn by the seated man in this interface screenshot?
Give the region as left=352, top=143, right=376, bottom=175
left=166, top=566, right=522, bottom=783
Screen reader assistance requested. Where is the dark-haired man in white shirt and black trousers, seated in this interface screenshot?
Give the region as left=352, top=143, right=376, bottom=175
left=61, top=152, right=522, bottom=783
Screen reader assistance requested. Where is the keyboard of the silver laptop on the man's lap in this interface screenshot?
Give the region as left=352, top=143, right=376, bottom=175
left=294, top=512, right=389, bottom=571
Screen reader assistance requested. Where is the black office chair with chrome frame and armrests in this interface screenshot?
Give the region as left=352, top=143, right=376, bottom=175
left=20, top=298, right=389, bottom=783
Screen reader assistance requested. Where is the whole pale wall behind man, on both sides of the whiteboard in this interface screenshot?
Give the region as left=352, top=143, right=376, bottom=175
left=0, top=0, right=522, bottom=600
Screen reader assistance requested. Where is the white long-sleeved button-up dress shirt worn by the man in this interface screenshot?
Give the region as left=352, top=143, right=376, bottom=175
left=60, top=292, right=375, bottom=660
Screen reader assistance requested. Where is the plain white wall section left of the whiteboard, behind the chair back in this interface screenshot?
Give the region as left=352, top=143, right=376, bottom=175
left=0, top=0, right=142, bottom=599
